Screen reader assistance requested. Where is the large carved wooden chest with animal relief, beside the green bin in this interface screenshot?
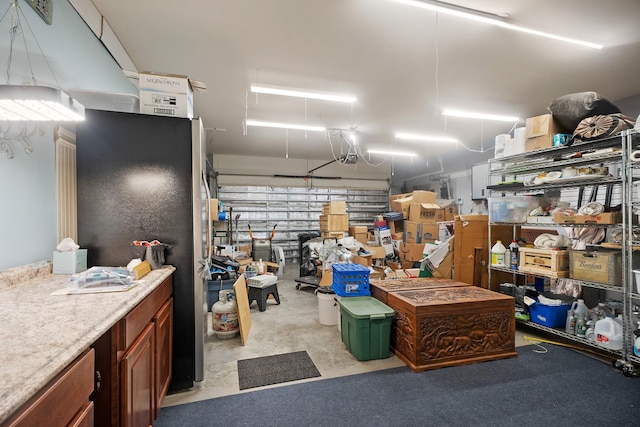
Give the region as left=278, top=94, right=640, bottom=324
left=387, top=286, right=517, bottom=372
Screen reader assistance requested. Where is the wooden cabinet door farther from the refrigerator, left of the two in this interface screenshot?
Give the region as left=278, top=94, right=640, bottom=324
left=120, top=323, right=155, bottom=427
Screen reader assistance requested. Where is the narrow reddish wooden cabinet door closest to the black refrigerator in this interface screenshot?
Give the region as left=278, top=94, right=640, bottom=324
left=153, top=298, right=173, bottom=417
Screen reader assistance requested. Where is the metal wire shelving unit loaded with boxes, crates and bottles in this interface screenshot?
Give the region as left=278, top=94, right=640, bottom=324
left=488, top=121, right=640, bottom=369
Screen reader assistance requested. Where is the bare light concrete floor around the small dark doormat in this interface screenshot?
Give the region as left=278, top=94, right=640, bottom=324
left=163, top=264, right=531, bottom=406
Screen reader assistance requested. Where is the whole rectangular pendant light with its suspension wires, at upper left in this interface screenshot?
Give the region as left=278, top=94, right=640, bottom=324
left=0, top=0, right=84, bottom=121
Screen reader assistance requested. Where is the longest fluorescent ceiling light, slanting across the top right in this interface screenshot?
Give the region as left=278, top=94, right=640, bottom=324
left=391, top=0, right=602, bottom=49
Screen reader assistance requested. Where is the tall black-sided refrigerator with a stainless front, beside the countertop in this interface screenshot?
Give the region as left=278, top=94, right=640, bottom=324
left=76, top=110, right=211, bottom=391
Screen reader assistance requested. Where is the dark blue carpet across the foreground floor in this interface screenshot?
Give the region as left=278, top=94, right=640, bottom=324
left=154, top=344, right=640, bottom=427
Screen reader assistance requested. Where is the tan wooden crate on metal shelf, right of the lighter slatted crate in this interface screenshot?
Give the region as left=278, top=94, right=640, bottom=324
left=569, top=251, right=622, bottom=286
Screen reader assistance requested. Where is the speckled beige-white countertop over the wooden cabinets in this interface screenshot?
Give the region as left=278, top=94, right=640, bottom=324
left=0, top=266, right=175, bottom=423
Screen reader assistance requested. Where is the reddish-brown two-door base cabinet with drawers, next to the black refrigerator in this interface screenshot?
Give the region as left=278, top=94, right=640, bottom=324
left=92, top=276, right=173, bottom=427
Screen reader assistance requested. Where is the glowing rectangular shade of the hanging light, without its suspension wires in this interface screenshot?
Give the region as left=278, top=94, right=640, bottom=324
left=0, top=85, right=84, bottom=122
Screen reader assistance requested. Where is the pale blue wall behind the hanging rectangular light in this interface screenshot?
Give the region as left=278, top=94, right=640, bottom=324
left=0, top=0, right=137, bottom=269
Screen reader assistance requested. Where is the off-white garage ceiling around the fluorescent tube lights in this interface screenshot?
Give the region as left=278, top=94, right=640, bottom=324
left=93, top=0, right=640, bottom=184
